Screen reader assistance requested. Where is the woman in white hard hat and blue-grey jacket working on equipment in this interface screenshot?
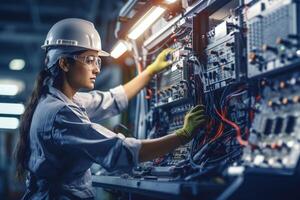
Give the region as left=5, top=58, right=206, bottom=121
left=17, top=18, right=205, bottom=199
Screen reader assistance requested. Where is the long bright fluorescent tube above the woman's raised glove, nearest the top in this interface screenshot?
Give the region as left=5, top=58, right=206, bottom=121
left=128, top=6, right=165, bottom=40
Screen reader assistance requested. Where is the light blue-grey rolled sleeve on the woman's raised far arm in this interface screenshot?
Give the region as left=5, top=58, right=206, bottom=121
left=74, top=85, right=128, bottom=122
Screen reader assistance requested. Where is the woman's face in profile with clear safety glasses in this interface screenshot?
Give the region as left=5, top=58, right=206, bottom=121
left=66, top=50, right=101, bottom=90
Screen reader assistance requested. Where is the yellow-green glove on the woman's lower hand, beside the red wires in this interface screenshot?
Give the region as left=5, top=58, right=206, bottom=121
left=175, top=105, right=206, bottom=144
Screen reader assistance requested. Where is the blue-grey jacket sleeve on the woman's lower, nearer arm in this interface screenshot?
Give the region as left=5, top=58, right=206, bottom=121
left=52, top=106, right=141, bottom=171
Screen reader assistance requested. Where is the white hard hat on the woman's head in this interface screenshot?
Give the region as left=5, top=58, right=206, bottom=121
left=42, top=18, right=109, bottom=56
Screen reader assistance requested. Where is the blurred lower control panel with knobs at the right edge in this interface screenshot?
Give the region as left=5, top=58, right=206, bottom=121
left=243, top=72, right=300, bottom=170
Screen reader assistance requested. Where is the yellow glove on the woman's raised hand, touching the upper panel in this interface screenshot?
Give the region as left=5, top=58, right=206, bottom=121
left=146, top=48, right=174, bottom=75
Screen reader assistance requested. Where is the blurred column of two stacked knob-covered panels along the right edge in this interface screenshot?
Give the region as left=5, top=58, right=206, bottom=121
left=242, top=0, right=300, bottom=172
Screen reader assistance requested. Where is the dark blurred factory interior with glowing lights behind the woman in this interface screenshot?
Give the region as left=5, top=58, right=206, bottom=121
left=0, top=0, right=134, bottom=199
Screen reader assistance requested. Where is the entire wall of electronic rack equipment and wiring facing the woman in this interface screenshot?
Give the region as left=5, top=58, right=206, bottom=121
left=91, top=0, right=300, bottom=200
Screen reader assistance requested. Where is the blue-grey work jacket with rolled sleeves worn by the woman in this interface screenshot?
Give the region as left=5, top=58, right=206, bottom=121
left=23, top=86, right=141, bottom=200
